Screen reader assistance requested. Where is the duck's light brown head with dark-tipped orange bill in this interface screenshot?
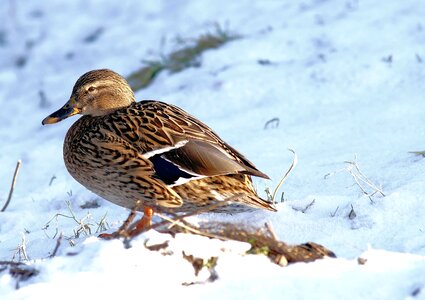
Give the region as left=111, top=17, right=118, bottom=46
left=42, top=69, right=135, bottom=125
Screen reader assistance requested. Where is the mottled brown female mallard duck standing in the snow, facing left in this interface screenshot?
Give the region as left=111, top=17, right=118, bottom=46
left=42, top=69, right=276, bottom=232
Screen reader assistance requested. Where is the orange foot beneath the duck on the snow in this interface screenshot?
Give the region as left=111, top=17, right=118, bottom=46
left=98, top=206, right=153, bottom=240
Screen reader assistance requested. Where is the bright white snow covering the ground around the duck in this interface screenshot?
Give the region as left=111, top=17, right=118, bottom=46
left=0, top=0, right=425, bottom=299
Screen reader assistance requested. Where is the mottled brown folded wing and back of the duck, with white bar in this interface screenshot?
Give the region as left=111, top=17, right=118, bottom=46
left=109, top=101, right=269, bottom=183
